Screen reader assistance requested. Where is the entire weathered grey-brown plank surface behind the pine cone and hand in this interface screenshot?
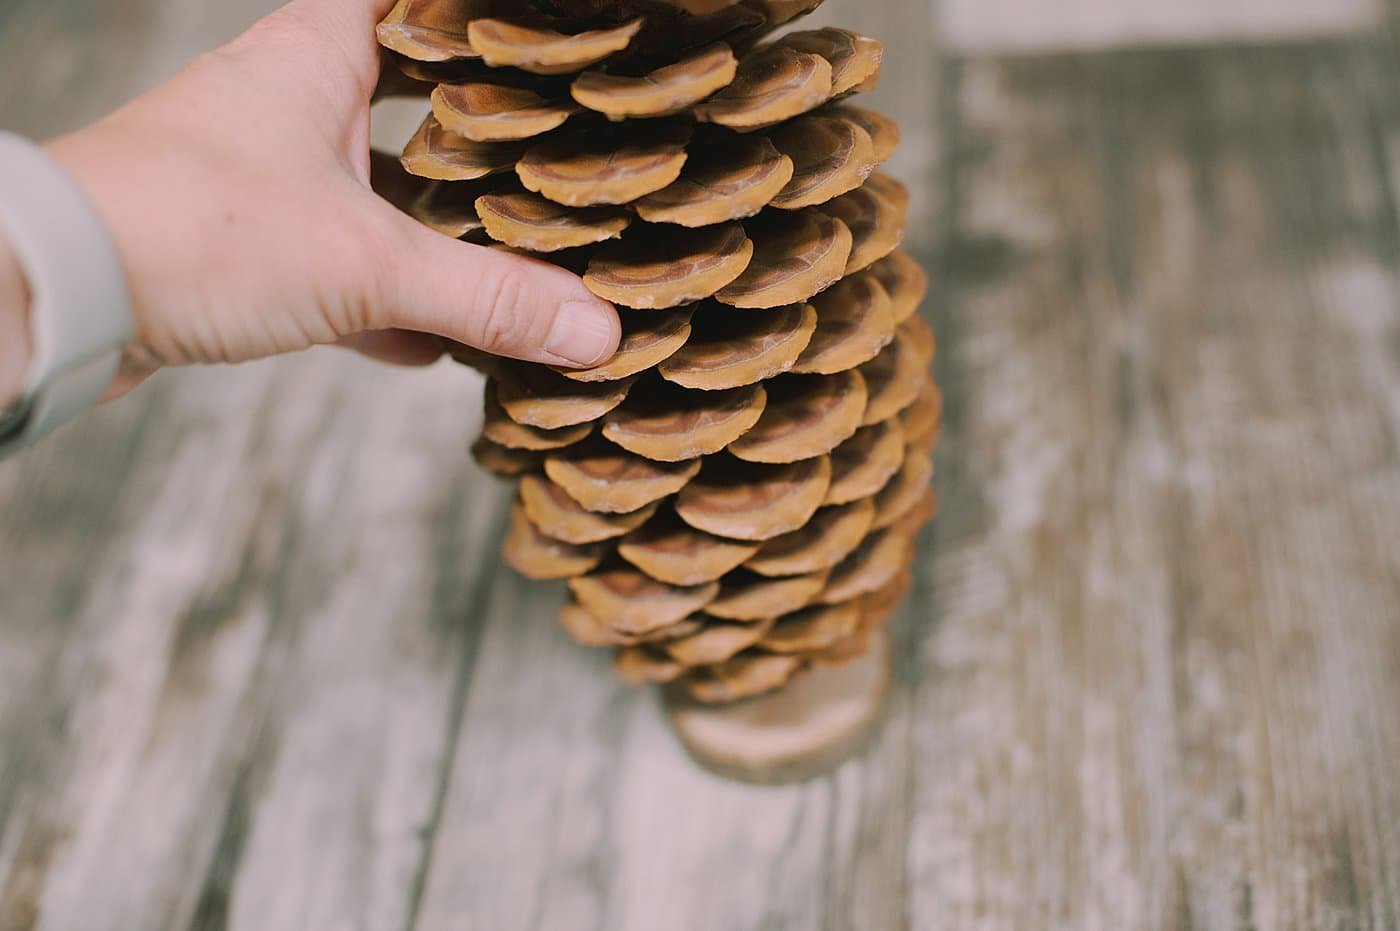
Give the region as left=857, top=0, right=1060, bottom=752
left=0, top=0, right=1400, bottom=931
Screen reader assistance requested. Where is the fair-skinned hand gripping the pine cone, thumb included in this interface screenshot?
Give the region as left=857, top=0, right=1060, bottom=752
left=42, top=0, right=620, bottom=393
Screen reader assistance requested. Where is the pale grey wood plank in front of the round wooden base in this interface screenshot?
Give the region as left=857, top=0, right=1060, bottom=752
left=414, top=565, right=899, bottom=931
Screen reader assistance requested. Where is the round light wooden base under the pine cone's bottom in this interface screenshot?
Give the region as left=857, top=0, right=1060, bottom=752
left=668, top=633, right=890, bottom=784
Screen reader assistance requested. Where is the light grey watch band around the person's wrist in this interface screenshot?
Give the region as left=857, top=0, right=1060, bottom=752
left=0, top=133, right=133, bottom=454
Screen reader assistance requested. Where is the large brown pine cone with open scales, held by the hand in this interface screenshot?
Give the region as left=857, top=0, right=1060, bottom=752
left=379, top=0, right=941, bottom=701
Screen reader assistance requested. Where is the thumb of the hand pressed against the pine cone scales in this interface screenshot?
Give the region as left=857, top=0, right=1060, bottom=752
left=368, top=200, right=622, bottom=368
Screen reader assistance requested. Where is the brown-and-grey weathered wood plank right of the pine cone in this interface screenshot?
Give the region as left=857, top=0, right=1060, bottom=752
left=909, top=45, right=1400, bottom=928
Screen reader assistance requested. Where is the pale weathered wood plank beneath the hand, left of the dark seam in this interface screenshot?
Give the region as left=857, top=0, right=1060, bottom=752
left=0, top=0, right=501, bottom=930
